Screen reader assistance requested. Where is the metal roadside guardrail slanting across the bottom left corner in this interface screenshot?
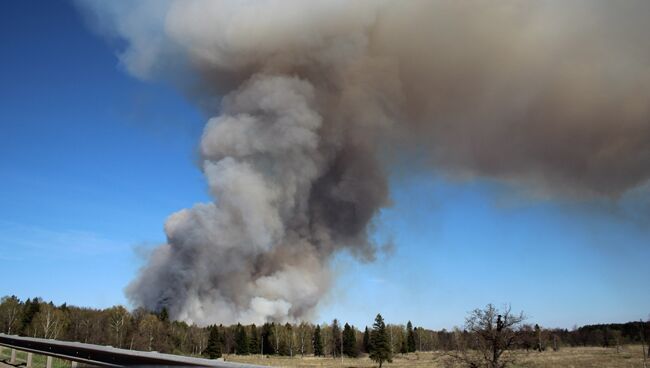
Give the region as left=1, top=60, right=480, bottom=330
left=0, top=333, right=262, bottom=368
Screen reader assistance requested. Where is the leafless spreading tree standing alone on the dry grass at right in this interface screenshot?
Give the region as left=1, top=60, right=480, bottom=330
left=450, top=304, right=526, bottom=368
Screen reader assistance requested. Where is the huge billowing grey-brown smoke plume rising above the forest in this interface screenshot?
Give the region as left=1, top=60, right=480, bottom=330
left=81, top=0, right=650, bottom=324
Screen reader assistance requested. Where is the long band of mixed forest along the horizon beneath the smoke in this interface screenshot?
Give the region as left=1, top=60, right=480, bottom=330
left=0, top=296, right=650, bottom=357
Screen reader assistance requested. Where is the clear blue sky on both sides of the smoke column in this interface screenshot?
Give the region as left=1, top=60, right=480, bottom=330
left=0, top=0, right=650, bottom=328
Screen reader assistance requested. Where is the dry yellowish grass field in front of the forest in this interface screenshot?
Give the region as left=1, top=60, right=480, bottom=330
left=225, top=346, right=643, bottom=368
